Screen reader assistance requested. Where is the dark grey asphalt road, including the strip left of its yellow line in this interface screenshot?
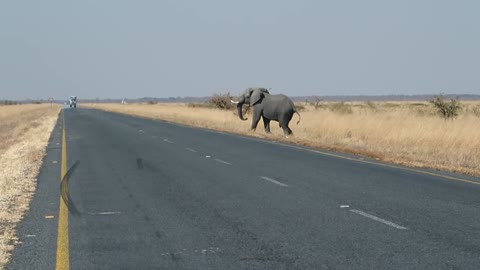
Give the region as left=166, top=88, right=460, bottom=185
left=9, top=109, right=480, bottom=269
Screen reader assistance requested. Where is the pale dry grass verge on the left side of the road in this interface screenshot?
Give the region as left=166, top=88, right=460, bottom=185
left=0, top=104, right=60, bottom=269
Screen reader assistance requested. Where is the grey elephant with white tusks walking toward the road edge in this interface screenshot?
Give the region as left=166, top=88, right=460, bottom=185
left=231, top=87, right=301, bottom=136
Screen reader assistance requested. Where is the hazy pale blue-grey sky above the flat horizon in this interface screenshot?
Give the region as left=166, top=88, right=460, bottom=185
left=0, top=0, right=480, bottom=99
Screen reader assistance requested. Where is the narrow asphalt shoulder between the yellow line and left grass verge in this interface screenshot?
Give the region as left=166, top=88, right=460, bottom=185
left=6, top=117, right=62, bottom=269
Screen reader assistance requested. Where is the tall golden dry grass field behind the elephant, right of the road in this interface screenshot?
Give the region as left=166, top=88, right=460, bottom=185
left=84, top=102, right=480, bottom=176
